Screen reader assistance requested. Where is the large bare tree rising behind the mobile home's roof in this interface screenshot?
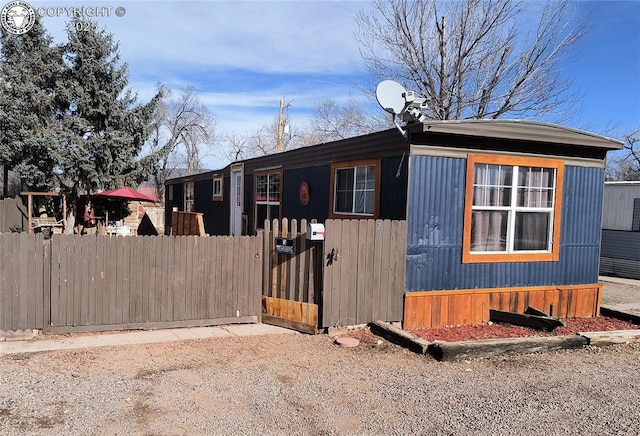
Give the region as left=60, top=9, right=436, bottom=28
left=356, top=0, right=586, bottom=120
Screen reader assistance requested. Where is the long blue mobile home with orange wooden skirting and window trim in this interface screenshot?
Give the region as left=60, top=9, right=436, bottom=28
left=166, top=120, right=622, bottom=327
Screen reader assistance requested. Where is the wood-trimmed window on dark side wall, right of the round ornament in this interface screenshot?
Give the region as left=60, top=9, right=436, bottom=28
left=329, top=159, right=380, bottom=218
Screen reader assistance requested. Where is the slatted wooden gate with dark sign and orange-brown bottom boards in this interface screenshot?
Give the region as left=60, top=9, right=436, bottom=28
left=262, top=218, right=322, bottom=334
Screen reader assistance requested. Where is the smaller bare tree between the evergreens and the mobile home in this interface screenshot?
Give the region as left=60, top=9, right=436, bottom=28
left=150, top=85, right=216, bottom=201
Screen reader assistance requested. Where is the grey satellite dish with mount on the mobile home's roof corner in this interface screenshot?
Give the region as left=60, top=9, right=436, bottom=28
left=376, top=80, right=427, bottom=138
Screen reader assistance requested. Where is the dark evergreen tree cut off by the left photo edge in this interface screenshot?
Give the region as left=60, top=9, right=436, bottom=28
left=0, top=20, right=62, bottom=197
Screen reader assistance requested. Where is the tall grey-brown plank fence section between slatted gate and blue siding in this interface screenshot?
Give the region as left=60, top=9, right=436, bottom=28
left=321, top=220, right=407, bottom=327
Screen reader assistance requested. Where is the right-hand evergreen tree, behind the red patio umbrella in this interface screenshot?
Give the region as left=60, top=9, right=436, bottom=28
left=56, top=21, right=157, bottom=197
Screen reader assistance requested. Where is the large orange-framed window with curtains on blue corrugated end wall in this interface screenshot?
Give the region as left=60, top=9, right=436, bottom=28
left=463, top=155, right=564, bottom=262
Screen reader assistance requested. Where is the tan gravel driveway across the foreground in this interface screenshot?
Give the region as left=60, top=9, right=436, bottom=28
left=0, top=335, right=640, bottom=435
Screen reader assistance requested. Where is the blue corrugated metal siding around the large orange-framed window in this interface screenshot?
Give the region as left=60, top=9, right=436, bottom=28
left=406, top=156, right=604, bottom=291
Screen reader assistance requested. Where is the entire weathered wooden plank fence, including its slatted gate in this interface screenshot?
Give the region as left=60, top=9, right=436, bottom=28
left=0, top=220, right=407, bottom=333
